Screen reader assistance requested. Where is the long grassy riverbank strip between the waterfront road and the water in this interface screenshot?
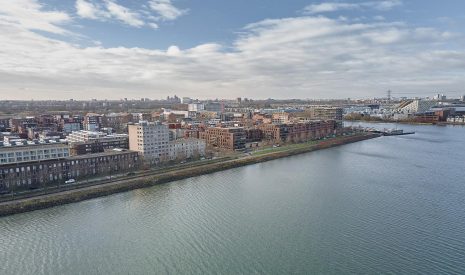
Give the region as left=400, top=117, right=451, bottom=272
left=0, top=133, right=379, bottom=216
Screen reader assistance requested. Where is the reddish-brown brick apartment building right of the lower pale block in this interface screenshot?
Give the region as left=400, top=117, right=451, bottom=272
left=200, top=127, right=246, bottom=150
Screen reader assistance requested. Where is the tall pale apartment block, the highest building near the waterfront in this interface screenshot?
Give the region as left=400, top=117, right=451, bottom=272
left=128, top=121, right=169, bottom=163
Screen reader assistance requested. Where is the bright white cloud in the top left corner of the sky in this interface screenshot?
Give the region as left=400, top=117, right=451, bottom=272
left=0, top=0, right=71, bottom=34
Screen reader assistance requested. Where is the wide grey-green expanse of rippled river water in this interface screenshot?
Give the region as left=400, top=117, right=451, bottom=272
left=0, top=124, right=465, bottom=274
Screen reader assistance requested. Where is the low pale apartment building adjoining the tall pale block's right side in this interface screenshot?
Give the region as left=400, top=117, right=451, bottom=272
left=169, top=138, right=206, bottom=160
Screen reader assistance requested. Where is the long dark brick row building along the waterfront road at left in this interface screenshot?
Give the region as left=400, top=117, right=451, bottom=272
left=0, top=151, right=139, bottom=190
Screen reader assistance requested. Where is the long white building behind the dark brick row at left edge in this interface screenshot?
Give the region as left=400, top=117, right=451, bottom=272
left=0, top=140, right=69, bottom=165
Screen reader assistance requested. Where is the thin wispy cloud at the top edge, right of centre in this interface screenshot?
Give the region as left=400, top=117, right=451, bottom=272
left=304, top=0, right=402, bottom=14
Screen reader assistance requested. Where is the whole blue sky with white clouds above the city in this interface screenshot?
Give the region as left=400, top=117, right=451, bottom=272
left=0, top=0, right=465, bottom=100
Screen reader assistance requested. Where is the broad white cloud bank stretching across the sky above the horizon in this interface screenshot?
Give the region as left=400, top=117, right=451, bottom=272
left=0, top=1, right=465, bottom=99
